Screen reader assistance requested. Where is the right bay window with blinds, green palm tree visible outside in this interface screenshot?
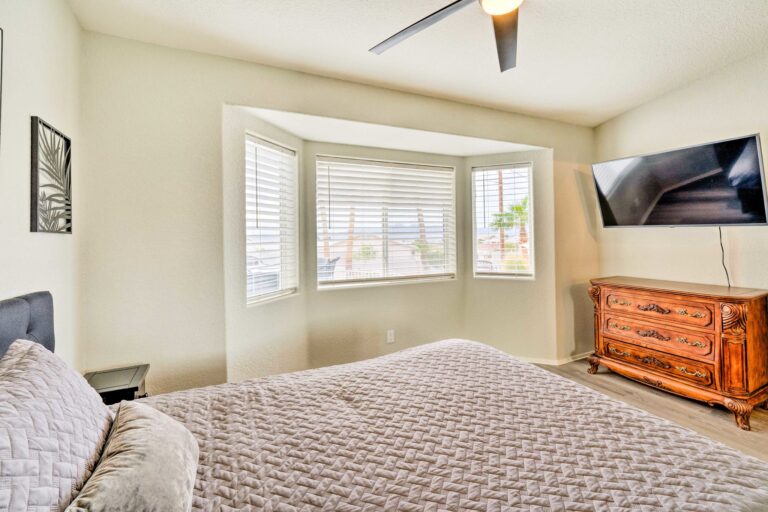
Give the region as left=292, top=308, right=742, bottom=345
left=472, top=163, right=534, bottom=277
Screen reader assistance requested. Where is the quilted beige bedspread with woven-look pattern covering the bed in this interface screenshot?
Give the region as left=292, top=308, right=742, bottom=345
left=141, top=340, right=768, bottom=512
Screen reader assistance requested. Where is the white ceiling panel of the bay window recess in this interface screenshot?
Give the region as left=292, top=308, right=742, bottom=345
left=247, top=108, right=542, bottom=156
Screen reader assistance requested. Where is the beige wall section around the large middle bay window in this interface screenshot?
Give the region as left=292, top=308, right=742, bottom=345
left=303, top=142, right=466, bottom=367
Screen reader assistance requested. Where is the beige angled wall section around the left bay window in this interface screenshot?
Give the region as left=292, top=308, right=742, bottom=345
left=222, top=106, right=309, bottom=382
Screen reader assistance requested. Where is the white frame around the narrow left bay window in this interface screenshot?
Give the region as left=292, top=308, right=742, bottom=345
left=242, top=130, right=302, bottom=308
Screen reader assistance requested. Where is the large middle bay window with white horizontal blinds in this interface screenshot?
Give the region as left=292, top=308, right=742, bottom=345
left=317, top=157, right=456, bottom=287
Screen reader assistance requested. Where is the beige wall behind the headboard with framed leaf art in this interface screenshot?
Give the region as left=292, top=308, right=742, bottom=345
left=0, top=0, right=84, bottom=367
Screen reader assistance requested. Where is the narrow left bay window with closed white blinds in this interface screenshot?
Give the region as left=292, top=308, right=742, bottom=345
left=245, top=135, right=299, bottom=303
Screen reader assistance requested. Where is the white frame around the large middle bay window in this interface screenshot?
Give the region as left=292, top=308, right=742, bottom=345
left=313, top=153, right=459, bottom=291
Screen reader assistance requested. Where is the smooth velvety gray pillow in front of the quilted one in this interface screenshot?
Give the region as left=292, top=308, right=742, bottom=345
left=67, top=402, right=198, bottom=512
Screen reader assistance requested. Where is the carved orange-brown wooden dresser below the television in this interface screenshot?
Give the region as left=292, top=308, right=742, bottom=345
left=589, top=277, right=768, bottom=430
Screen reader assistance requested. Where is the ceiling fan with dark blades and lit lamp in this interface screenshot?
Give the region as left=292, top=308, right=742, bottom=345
left=369, top=0, right=524, bottom=72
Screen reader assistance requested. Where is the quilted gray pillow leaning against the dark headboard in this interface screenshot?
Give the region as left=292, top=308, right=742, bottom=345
left=0, top=340, right=112, bottom=511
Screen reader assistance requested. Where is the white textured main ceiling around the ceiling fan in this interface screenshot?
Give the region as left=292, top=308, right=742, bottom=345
left=70, top=0, right=768, bottom=126
